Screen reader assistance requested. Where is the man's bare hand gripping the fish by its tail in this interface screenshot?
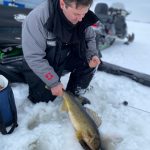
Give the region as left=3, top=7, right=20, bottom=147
left=51, top=83, right=64, bottom=96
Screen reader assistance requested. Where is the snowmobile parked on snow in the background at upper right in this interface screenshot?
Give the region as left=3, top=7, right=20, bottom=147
left=92, top=3, right=134, bottom=50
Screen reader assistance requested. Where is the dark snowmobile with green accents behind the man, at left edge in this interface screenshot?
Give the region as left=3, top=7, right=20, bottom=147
left=0, top=3, right=32, bottom=82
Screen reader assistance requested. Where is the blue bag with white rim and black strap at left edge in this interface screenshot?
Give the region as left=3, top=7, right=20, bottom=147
left=0, top=75, right=18, bottom=135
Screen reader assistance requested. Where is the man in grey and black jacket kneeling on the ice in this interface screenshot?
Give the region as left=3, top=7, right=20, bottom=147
left=22, top=0, right=101, bottom=104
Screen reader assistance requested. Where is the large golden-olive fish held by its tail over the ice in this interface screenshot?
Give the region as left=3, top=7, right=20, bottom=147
left=62, top=91, right=101, bottom=150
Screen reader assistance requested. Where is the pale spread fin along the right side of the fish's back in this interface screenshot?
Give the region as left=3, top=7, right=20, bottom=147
left=84, top=107, right=102, bottom=127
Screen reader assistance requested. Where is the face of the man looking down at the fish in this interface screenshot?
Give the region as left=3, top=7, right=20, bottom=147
left=60, top=0, right=90, bottom=24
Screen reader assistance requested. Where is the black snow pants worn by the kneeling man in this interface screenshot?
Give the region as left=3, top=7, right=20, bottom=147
left=23, top=52, right=95, bottom=103
